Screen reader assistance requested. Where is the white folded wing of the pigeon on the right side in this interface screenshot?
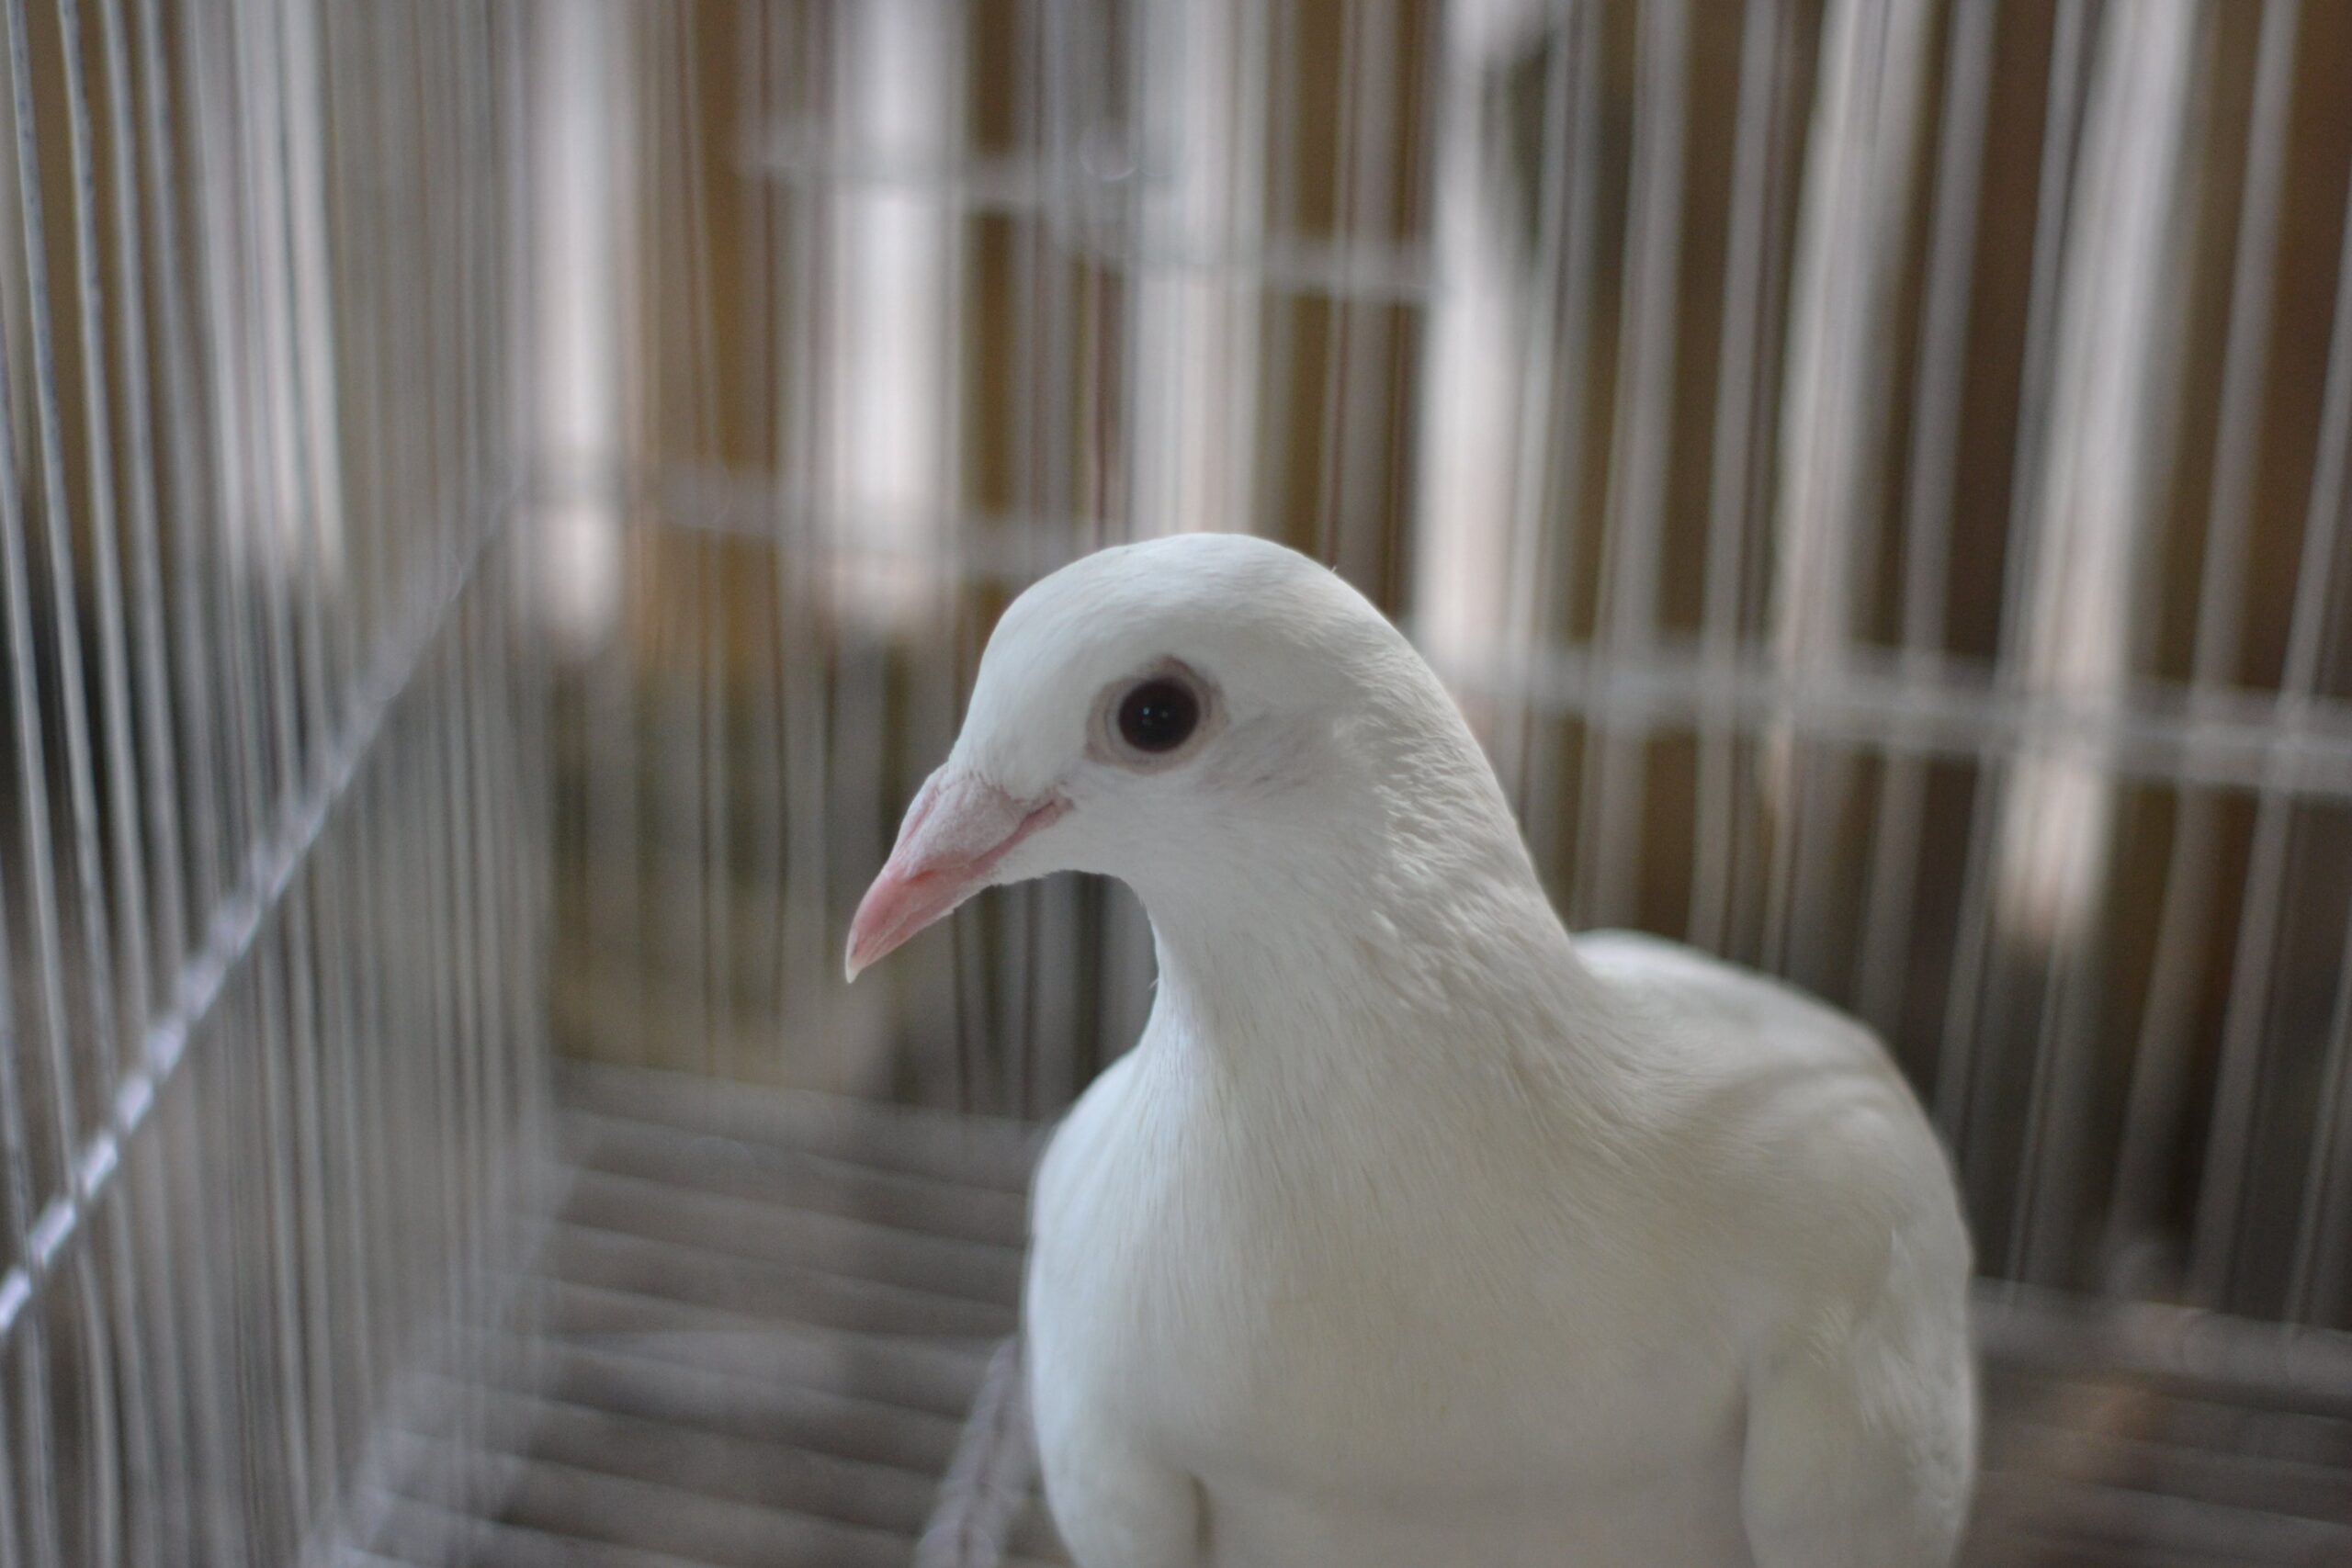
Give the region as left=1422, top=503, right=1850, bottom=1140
left=1578, top=933, right=1975, bottom=1568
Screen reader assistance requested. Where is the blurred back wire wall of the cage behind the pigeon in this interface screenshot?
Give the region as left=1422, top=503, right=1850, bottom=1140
left=545, top=0, right=2352, bottom=1324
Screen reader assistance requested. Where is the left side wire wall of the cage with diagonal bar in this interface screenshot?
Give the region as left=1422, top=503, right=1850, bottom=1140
left=0, top=0, right=548, bottom=1568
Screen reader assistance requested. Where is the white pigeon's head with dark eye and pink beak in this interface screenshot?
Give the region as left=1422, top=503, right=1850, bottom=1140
left=847, top=534, right=1517, bottom=978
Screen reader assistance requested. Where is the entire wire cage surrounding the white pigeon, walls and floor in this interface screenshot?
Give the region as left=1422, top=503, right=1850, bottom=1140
left=0, top=0, right=2352, bottom=1568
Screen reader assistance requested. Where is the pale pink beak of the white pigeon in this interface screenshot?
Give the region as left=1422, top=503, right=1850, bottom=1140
left=847, top=764, right=1070, bottom=980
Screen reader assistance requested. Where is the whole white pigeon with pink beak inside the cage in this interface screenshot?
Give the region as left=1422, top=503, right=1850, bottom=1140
left=849, top=534, right=1975, bottom=1568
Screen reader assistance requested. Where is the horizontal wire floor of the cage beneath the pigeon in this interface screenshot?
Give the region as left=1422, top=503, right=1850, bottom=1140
left=350, top=1069, right=2352, bottom=1568
